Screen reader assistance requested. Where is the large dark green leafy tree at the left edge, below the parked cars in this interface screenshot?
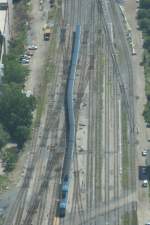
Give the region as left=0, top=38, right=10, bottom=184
left=0, top=83, right=35, bottom=146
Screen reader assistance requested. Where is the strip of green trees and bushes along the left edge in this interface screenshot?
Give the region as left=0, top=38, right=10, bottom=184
left=0, top=0, right=35, bottom=175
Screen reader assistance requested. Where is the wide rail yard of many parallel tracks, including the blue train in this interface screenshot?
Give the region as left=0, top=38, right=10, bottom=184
left=0, top=0, right=149, bottom=225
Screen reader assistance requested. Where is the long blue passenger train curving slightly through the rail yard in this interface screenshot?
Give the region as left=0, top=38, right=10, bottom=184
left=59, top=25, right=81, bottom=217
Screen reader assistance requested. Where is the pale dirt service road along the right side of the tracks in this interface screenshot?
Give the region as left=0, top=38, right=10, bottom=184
left=124, top=0, right=150, bottom=225
